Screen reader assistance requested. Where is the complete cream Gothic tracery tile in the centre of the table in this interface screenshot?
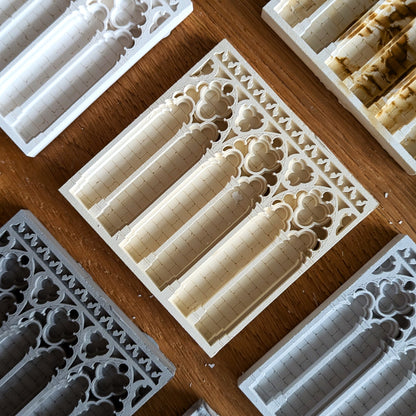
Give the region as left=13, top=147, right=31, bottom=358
left=61, top=41, right=376, bottom=356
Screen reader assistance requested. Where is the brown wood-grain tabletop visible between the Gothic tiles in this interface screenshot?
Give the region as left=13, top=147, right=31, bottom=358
left=0, top=0, right=416, bottom=416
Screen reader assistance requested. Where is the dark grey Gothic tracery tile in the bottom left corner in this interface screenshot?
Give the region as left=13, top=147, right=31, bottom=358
left=0, top=211, right=175, bottom=416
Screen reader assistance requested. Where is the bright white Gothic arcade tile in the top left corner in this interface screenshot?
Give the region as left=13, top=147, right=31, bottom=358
left=0, top=0, right=192, bottom=156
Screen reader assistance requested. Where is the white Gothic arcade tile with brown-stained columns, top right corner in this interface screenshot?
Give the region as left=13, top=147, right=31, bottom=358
left=263, top=0, right=416, bottom=175
